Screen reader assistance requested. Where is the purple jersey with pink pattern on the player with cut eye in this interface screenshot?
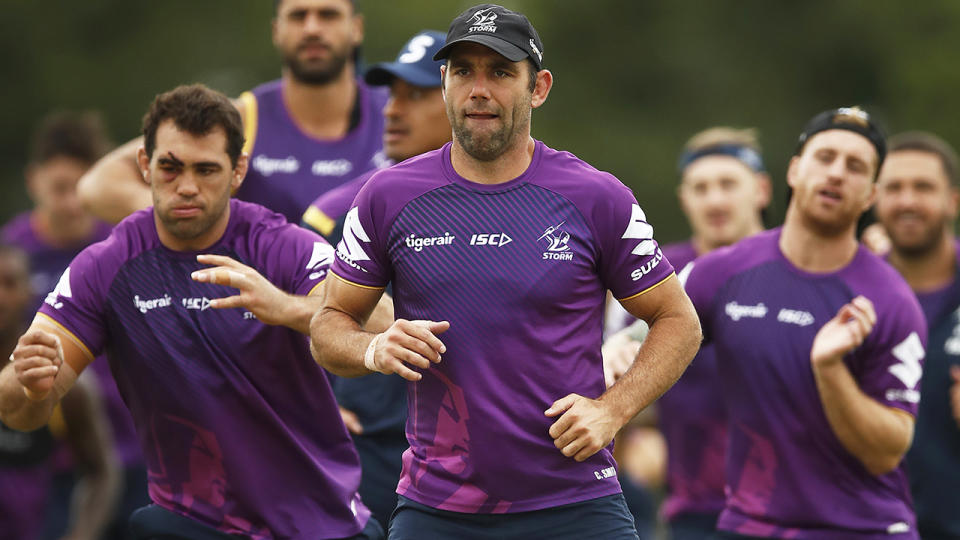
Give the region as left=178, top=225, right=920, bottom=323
left=40, top=200, right=369, bottom=539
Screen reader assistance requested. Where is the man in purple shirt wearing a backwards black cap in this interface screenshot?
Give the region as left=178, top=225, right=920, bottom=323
left=682, top=107, right=927, bottom=540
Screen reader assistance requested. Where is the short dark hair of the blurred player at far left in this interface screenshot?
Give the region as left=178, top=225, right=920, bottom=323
left=30, top=111, right=112, bottom=166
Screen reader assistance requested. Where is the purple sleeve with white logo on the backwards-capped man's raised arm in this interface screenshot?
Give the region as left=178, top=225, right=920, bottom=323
left=853, top=295, right=927, bottom=416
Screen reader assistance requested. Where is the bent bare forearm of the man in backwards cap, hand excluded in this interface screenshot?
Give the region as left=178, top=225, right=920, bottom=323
left=813, top=361, right=913, bottom=475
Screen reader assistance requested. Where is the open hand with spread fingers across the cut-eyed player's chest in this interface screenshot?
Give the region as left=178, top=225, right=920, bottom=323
left=190, top=255, right=290, bottom=325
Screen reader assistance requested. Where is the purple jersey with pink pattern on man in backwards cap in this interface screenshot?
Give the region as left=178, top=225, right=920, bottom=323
left=686, top=229, right=927, bottom=540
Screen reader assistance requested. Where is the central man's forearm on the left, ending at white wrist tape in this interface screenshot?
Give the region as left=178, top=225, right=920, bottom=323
left=310, top=307, right=376, bottom=377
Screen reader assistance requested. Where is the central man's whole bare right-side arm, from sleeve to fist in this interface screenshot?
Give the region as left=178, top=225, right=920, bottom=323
left=545, top=276, right=702, bottom=461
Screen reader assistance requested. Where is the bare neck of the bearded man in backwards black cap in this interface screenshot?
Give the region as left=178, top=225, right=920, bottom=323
left=780, top=206, right=859, bottom=274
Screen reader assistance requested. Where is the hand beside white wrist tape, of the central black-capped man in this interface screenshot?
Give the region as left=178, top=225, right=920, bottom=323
left=363, top=319, right=450, bottom=381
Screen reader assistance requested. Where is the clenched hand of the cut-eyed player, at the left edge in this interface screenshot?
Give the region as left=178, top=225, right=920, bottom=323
left=10, top=329, right=63, bottom=401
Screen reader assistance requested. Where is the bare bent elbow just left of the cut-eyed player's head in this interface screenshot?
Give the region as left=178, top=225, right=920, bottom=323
left=77, top=137, right=153, bottom=223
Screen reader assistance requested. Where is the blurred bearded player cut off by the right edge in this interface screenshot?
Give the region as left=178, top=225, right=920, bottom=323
left=875, top=132, right=960, bottom=540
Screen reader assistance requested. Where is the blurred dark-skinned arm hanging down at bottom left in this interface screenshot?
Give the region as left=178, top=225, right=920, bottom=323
left=61, top=377, right=123, bottom=540
